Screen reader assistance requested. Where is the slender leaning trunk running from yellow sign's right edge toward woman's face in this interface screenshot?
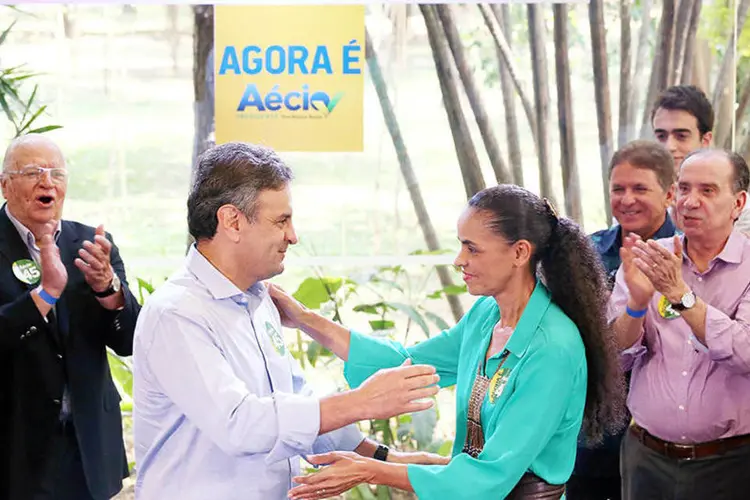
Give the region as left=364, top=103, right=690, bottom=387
left=365, top=31, right=464, bottom=322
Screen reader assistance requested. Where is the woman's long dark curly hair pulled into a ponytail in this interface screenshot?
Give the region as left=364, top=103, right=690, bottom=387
left=469, top=184, right=625, bottom=443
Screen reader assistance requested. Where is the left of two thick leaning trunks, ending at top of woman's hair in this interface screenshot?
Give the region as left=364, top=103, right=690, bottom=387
left=419, top=4, right=485, bottom=198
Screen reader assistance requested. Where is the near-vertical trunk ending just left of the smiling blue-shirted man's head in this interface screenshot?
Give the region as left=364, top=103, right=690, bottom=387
left=589, top=0, right=613, bottom=223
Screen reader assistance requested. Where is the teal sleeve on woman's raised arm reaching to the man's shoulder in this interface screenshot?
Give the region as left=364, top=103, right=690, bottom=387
left=344, top=306, right=468, bottom=387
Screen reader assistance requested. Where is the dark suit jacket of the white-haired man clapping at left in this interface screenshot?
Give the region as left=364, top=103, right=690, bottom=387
left=0, top=207, right=140, bottom=500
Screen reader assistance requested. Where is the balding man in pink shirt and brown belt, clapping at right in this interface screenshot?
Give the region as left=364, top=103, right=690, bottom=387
left=609, top=150, right=750, bottom=500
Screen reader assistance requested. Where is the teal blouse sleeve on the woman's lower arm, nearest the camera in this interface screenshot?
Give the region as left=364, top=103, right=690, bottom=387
left=408, top=345, right=586, bottom=500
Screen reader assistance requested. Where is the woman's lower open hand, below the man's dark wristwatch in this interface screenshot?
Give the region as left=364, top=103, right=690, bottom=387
left=289, top=451, right=382, bottom=500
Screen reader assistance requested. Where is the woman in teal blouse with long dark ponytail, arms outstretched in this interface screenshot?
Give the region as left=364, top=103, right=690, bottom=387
left=270, top=185, right=622, bottom=500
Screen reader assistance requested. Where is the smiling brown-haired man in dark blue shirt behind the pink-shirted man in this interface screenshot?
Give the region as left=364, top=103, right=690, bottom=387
left=566, top=141, right=676, bottom=500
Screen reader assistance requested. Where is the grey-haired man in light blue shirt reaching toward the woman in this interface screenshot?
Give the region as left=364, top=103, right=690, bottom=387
left=133, top=143, right=437, bottom=500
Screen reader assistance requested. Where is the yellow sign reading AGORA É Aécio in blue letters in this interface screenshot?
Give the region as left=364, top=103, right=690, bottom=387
left=214, top=5, right=365, bottom=152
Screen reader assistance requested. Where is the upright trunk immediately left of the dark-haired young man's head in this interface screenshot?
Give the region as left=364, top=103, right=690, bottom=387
left=640, top=0, right=675, bottom=138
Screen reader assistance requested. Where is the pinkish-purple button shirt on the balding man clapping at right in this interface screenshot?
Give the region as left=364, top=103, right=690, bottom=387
left=608, top=230, right=750, bottom=443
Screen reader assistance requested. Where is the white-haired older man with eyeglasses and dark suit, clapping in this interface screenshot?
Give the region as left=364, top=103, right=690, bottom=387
left=0, top=134, right=140, bottom=500
